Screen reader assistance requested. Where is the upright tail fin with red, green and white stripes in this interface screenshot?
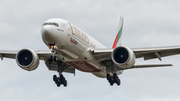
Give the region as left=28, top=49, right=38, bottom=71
left=112, top=17, right=124, bottom=48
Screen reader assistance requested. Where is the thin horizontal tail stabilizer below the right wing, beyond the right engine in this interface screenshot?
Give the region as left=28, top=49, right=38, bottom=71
left=129, top=64, right=173, bottom=69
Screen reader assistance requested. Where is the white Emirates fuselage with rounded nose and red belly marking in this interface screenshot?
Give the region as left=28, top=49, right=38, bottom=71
left=41, top=18, right=106, bottom=78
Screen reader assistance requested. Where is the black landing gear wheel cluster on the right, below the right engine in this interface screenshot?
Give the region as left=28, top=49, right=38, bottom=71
left=107, top=73, right=121, bottom=86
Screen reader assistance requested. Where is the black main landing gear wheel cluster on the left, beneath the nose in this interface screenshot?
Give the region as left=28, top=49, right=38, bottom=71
left=53, top=74, right=67, bottom=87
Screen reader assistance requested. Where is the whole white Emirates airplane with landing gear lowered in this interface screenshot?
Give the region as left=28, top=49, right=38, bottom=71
left=0, top=17, right=180, bottom=87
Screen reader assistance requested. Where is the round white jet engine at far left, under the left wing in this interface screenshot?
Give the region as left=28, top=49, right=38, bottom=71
left=16, top=49, right=39, bottom=71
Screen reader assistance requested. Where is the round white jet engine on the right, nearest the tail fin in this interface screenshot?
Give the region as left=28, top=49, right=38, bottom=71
left=111, top=46, right=136, bottom=69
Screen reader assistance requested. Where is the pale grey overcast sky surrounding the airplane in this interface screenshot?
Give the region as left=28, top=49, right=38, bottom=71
left=0, top=0, right=180, bottom=101
